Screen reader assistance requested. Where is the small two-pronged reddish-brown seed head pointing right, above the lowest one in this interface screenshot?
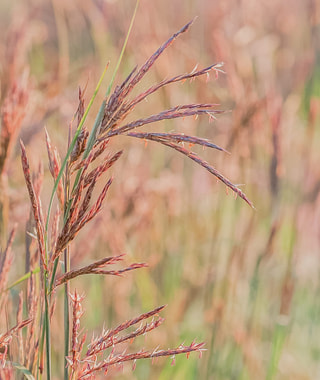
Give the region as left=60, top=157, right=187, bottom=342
left=55, top=254, right=148, bottom=287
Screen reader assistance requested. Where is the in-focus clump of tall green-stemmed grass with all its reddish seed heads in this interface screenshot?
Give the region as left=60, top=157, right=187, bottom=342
left=15, top=7, right=252, bottom=380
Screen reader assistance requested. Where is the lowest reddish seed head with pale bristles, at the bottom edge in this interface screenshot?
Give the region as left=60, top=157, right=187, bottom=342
left=67, top=298, right=204, bottom=379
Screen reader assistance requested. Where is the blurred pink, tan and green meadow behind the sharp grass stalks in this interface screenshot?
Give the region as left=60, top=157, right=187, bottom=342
left=0, top=0, right=320, bottom=380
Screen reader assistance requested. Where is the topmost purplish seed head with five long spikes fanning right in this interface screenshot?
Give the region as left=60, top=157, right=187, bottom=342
left=78, top=21, right=253, bottom=207
